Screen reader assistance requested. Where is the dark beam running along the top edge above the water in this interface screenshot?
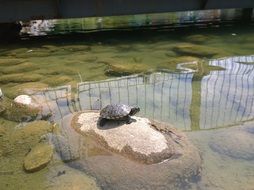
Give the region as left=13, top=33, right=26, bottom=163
left=0, top=0, right=254, bottom=23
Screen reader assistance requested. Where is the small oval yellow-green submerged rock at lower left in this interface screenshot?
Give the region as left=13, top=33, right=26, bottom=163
left=24, top=143, right=53, bottom=172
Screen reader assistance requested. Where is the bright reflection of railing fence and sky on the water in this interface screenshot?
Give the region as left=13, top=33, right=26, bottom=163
left=34, top=56, right=254, bottom=130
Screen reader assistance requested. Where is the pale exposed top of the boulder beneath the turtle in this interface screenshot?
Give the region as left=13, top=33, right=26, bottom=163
left=72, top=112, right=190, bottom=164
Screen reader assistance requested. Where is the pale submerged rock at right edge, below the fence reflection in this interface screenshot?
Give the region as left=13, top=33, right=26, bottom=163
left=209, top=127, right=254, bottom=160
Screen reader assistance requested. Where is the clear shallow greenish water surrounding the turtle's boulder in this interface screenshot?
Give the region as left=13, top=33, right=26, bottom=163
left=0, top=24, right=254, bottom=190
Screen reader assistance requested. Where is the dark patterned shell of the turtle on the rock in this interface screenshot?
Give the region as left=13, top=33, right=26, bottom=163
left=100, top=104, right=132, bottom=119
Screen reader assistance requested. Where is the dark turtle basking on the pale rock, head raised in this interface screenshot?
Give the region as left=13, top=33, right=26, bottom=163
left=99, top=104, right=140, bottom=127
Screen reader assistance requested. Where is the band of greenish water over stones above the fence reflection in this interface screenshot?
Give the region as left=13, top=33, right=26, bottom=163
left=0, top=27, right=254, bottom=90
